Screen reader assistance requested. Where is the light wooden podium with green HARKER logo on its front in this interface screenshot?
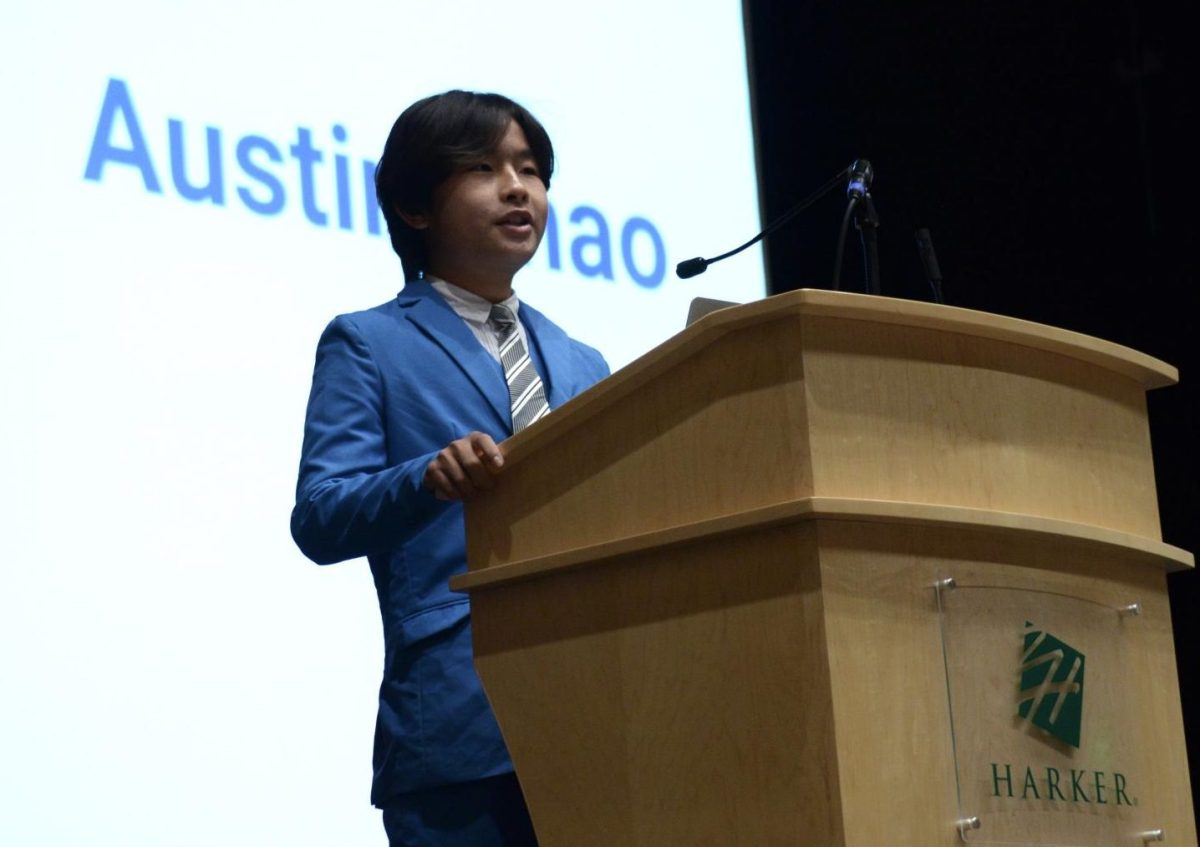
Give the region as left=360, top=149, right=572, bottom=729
left=454, top=290, right=1196, bottom=847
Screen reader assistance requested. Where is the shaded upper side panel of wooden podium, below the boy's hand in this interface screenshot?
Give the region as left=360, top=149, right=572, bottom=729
left=467, top=320, right=812, bottom=567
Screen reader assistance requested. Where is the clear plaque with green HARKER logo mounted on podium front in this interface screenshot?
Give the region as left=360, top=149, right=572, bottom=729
left=936, top=576, right=1148, bottom=847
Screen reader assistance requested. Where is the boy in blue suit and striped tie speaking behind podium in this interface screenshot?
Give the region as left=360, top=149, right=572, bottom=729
left=292, top=91, right=608, bottom=847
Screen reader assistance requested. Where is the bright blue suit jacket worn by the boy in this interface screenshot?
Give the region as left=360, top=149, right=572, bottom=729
left=292, top=282, right=608, bottom=806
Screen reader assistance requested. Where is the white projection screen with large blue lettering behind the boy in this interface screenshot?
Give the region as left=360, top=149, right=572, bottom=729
left=0, top=0, right=764, bottom=846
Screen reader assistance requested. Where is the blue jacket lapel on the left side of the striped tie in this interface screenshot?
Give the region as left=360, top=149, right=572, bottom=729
left=400, top=282, right=512, bottom=427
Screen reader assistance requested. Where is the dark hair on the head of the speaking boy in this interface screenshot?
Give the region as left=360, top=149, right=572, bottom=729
left=376, top=91, right=554, bottom=280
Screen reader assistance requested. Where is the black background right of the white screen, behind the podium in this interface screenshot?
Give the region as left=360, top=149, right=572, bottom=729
left=744, top=0, right=1200, bottom=798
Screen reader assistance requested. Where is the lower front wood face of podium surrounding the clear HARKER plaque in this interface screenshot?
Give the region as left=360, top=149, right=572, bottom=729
left=817, top=522, right=1196, bottom=847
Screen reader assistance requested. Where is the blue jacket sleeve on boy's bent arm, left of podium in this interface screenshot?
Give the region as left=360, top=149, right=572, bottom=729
left=292, top=316, right=445, bottom=565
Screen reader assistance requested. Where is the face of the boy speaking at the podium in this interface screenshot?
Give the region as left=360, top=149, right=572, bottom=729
left=404, top=121, right=547, bottom=301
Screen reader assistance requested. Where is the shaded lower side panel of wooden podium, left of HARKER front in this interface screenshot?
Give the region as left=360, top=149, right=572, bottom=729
left=473, top=525, right=841, bottom=847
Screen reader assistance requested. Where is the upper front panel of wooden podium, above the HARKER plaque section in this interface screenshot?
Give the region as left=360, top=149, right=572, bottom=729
left=803, top=318, right=1162, bottom=539
